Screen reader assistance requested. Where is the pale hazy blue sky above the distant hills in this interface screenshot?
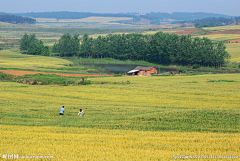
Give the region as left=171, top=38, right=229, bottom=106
left=0, top=0, right=240, bottom=16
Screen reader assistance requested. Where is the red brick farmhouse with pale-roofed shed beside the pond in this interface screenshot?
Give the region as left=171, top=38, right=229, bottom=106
left=128, top=66, right=157, bottom=76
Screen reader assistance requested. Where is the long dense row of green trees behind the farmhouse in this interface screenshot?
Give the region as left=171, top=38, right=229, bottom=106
left=53, top=32, right=230, bottom=67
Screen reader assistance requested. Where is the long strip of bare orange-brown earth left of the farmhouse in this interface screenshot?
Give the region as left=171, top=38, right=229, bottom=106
left=0, top=70, right=113, bottom=77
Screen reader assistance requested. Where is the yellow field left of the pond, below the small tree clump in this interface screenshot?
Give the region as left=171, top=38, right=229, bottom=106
left=0, top=50, right=71, bottom=69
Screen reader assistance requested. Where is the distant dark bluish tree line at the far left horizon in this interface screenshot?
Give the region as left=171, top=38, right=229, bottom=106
left=0, top=14, right=36, bottom=24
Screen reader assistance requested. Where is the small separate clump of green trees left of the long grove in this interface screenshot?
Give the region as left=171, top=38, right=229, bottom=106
left=20, top=34, right=50, bottom=56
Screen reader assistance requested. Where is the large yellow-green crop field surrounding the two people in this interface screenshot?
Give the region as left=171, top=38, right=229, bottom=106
left=0, top=74, right=240, bottom=160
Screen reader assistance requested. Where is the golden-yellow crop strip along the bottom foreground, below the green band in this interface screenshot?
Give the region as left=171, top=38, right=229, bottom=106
left=0, top=125, right=240, bottom=160
